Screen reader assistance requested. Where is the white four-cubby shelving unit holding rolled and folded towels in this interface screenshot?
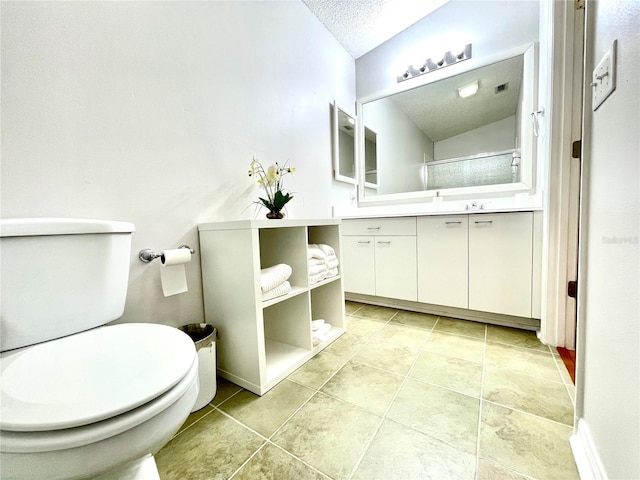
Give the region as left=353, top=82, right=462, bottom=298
left=198, top=219, right=345, bottom=395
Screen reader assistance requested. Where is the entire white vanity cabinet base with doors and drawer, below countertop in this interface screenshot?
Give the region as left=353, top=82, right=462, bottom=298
left=343, top=209, right=542, bottom=330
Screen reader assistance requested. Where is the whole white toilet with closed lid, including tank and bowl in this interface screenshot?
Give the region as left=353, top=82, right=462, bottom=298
left=0, top=218, right=199, bottom=480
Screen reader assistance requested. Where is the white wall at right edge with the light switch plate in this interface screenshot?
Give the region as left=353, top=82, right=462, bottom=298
left=577, top=0, right=640, bottom=479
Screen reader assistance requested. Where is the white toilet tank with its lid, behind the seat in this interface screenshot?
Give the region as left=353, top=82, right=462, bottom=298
left=0, top=218, right=134, bottom=351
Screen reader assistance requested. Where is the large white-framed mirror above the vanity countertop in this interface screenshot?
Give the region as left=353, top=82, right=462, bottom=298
left=358, top=45, right=537, bottom=203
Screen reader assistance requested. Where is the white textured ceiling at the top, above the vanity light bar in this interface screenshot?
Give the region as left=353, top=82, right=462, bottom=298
left=302, top=0, right=448, bottom=58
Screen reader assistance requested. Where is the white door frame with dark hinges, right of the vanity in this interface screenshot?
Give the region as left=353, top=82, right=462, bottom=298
left=539, top=1, right=584, bottom=349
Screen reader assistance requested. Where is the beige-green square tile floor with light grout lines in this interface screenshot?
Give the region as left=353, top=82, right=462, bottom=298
left=156, top=302, right=579, bottom=480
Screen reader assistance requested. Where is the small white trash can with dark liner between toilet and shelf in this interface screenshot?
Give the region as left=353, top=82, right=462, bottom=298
left=179, top=323, right=218, bottom=413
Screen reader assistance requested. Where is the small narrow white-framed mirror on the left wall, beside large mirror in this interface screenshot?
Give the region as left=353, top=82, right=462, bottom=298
left=332, top=102, right=358, bottom=185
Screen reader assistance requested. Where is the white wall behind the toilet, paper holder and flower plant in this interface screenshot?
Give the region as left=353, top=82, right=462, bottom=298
left=1, top=2, right=355, bottom=325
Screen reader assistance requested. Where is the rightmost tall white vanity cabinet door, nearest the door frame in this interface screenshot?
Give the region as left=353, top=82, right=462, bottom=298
left=469, top=212, right=533, bottom=318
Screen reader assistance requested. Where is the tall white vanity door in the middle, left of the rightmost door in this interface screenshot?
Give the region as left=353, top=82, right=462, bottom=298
left=417, top=215, right=469, bottom=308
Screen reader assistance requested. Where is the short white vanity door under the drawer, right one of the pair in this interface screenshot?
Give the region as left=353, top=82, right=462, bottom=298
left=375, top=235, right=417, bottom=302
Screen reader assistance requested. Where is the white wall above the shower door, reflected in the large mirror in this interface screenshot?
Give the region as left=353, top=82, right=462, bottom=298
left=433, top=115, right=516, bottom=160
